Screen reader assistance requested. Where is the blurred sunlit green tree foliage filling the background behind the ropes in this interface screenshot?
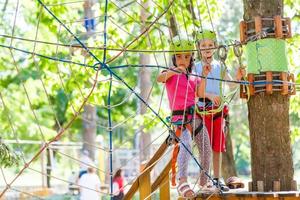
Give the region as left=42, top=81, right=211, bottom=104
left=0, top=0, right=300, bottom=180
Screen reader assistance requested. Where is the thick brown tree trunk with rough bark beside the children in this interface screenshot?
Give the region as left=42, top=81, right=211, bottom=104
left=244, top=0, right=294, bottom=191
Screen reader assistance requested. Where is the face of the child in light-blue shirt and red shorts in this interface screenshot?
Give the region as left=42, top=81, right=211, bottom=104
left=198, top=39, right=215, bottom=63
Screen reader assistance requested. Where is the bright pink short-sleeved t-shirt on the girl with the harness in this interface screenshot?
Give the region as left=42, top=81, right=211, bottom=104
left=166, top=74, right=200, bottom=122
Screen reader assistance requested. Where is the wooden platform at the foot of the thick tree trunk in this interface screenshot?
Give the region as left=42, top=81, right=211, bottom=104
left=178, top=191, right=300, bottom=200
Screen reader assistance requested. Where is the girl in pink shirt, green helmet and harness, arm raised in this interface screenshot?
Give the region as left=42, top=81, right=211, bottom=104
left=157, top=36, right=211, bottom=198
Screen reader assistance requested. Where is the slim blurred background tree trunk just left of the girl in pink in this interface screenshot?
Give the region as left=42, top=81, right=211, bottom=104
left=138, top=0, right=151, bottom=163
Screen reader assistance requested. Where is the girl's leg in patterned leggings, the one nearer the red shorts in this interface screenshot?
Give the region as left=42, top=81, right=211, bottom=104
left=194, top=119, right=212, bottom=186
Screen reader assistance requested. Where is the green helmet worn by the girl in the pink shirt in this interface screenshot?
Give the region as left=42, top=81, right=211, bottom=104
left=170, top=35, right=195, bottom=54
